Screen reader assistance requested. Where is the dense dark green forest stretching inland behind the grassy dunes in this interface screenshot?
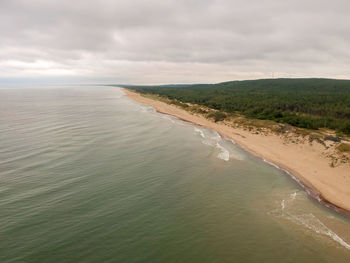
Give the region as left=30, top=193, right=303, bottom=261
left=124, top=79, right=350, bottom=134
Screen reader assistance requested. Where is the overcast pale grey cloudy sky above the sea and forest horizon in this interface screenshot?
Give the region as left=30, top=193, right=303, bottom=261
left=0, top=0, right=350, bottom=84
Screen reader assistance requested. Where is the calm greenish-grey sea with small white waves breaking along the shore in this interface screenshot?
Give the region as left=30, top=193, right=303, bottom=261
left=0, top=86, right=350, bottom=263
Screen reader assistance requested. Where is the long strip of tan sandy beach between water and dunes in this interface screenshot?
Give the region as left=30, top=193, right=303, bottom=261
left=122, top=88, right=350, bottom=216
